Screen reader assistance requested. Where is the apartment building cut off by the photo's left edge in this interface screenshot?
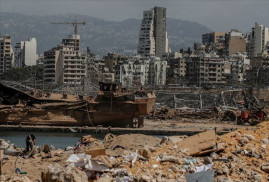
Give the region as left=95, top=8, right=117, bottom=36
left=0, top=36, right=14, bottom=74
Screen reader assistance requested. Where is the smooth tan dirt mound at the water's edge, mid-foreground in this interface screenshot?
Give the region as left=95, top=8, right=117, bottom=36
left=105, top=134, right=161, bottom=156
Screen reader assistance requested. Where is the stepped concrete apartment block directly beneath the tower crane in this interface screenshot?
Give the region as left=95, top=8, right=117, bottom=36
left=44, top=35, right=86, bottom=84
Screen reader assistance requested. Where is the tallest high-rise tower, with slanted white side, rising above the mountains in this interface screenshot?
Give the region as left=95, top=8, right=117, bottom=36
left=137, top=7, right=169, bottom=57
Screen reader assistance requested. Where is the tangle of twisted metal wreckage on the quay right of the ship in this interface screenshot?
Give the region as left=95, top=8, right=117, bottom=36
left=152, top=89, right=268, bottom=125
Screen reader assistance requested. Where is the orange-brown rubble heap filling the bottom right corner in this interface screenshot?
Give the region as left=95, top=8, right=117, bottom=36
left=214, top=121, right=269, bottom=181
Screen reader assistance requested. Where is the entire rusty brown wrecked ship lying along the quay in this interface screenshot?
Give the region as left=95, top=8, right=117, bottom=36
left=0, top=83, right=155, bottom=127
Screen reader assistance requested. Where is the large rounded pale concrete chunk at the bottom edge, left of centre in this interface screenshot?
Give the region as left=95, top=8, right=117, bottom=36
left=41, top=163, right=88, bottom=182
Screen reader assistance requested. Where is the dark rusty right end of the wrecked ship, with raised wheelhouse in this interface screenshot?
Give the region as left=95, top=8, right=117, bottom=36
left=89, top=83, right=156, bottom=127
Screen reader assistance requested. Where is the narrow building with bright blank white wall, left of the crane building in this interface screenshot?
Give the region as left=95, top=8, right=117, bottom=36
left=14, top=38, right=37, bottom=68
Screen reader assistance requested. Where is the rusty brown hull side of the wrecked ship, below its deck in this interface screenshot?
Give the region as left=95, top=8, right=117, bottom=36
left=0, top=98, right=155, bottom=127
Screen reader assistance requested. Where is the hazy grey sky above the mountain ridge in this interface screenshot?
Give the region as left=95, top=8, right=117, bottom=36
left=0, top=0, right=269, bottom=32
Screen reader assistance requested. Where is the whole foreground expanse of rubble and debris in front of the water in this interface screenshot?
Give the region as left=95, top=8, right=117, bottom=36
left=0, top=121, right=269, bottom=182
